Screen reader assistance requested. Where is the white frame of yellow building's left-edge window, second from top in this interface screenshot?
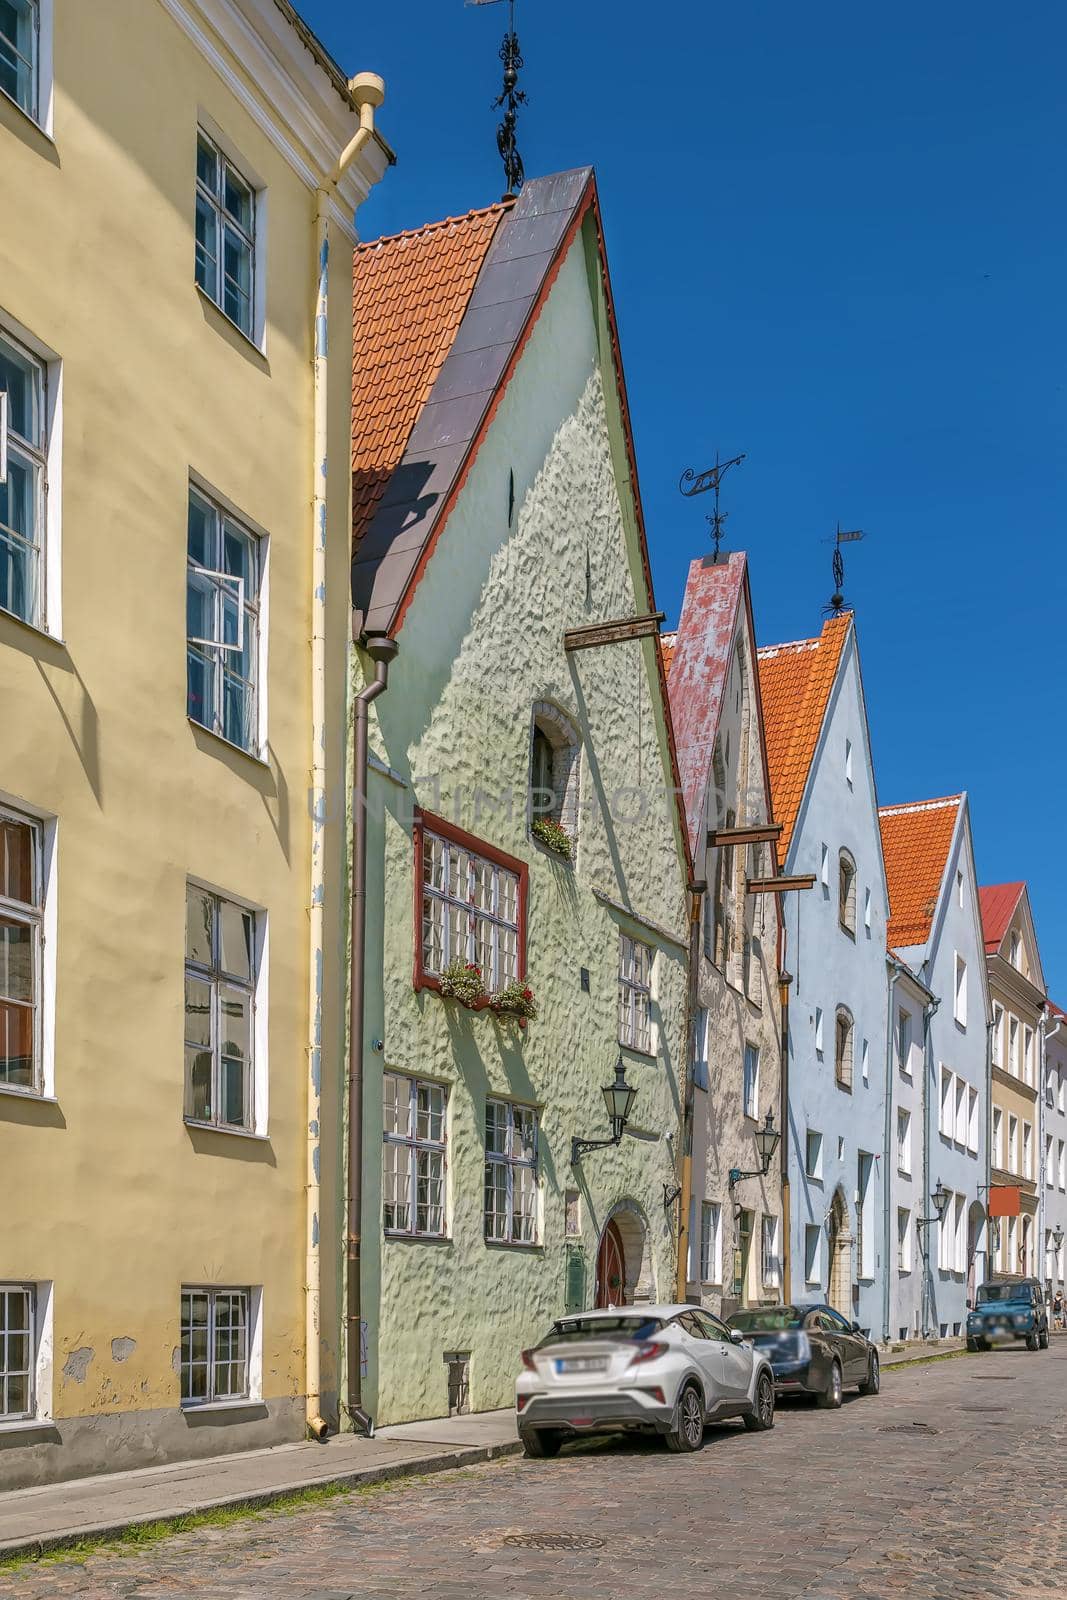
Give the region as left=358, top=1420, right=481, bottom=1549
left=0, top=310, right=62, bottom=638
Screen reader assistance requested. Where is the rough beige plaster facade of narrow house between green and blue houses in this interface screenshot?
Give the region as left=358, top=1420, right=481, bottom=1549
left=688, top=606, right=784, bottom=1312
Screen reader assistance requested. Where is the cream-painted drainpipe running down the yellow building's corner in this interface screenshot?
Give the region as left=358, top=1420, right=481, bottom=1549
left=304, top=72, right=386, bottom=1440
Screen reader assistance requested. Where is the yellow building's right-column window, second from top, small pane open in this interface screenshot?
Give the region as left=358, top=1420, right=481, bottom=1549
left=186, top=485, right=267, bottom=755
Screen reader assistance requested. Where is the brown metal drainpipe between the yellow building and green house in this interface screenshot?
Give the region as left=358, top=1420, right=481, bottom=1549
left=346, top=637, right=398, bottom=1434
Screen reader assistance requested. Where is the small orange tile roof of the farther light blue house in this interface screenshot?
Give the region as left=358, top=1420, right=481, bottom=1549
left=878, top=795, right=963, bottom=947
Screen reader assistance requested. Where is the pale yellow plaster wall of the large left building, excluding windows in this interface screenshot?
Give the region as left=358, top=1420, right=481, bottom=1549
left=0, top=0, right=352, bottom=1483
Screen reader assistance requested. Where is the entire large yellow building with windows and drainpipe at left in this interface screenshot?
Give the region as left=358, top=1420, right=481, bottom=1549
left=0, top=0, right=390, bottom=1488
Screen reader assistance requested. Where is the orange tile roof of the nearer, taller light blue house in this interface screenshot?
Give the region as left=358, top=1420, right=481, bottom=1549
left=757, top=611, right=853, bottom=861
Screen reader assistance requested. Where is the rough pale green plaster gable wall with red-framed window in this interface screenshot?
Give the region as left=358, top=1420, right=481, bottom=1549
left=363, top=228, right=686, bottom=1422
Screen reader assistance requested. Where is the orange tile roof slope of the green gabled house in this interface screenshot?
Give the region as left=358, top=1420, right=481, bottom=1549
left=352, top=202, right=514, bottom=547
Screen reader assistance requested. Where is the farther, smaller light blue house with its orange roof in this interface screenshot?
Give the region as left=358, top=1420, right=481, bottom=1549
left=880, top=794, right=990, bottom=1339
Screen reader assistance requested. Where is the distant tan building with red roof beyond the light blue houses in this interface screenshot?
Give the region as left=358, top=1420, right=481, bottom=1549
left=979, top=883, right=1045, bottom=1278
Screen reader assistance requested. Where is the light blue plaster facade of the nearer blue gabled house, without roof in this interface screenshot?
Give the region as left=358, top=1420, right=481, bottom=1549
left=785, top=634, right=888, bottom=1334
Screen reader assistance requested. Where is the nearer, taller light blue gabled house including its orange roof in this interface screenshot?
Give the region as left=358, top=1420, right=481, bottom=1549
left=758, top=613, right=889, bottom=1338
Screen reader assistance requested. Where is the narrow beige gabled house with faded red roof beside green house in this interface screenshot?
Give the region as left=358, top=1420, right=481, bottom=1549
left=664, top=555, right=784, bottom=1315
